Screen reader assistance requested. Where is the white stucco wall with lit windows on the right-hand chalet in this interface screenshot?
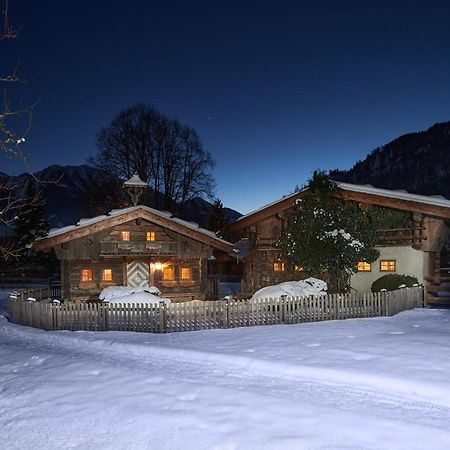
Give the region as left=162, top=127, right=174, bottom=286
left=350, top=246, right=428, bottom=292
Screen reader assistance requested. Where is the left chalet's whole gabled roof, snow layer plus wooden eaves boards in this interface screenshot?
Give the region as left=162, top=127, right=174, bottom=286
left=34, top=205, right=233, bottom=253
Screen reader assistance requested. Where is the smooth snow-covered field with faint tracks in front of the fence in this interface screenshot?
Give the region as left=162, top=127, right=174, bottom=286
left=0, top=293, right=450, bottom=450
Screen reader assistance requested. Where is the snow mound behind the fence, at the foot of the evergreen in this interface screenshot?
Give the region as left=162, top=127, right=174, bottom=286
left=251, top=277, right=328, bottom=300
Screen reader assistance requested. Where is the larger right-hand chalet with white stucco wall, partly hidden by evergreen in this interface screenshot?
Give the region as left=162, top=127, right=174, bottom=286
left=228, top=183, right=450, bottom=303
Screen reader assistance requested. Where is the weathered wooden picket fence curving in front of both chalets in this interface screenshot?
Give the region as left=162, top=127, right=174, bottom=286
left=9, top=287, right=423, bottom=333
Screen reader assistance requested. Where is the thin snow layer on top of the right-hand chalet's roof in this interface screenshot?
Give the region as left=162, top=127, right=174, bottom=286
left=234, top=182, right=450, bottom=224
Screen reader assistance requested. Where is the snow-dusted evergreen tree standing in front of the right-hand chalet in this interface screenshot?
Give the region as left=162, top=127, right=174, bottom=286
left=281, top=171, right=379, bottom=292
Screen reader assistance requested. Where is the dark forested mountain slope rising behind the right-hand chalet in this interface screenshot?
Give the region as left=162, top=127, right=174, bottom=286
left=330, top=122, right=450, bottom=199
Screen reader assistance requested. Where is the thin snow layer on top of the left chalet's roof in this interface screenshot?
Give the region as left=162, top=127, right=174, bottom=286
left=36, top=205, right=232, bottom=250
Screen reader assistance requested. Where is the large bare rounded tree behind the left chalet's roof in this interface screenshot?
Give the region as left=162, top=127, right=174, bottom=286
left=88, top=103, right=215, bottom=209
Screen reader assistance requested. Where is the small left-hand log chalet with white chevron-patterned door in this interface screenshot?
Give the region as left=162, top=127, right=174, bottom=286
left=34, top=206, right=233, bottom=301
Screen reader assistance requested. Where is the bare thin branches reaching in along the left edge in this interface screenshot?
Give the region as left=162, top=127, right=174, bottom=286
left=0, top=0, right=35, bottom=259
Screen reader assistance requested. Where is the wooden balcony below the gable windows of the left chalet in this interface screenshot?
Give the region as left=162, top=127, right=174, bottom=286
left=100, top=241, right=177, bottom=257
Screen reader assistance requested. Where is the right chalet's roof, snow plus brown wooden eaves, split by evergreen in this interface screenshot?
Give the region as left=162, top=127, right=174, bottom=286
left=229, top=182, right=450, bottom=231
